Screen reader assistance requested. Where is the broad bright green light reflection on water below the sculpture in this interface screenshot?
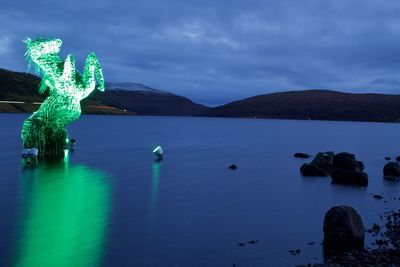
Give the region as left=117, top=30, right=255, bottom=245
left=16, top=161, right=110, bottom=266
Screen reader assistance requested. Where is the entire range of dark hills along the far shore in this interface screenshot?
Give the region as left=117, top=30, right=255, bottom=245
left=0, top=69, right=400, bottom=122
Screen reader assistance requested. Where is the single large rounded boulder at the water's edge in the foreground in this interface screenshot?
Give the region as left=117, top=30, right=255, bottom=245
left=323, top=206, right=364, bottom=251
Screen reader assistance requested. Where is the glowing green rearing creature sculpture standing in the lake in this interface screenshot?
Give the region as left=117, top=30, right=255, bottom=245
left=21, top=38, right=104, bottom=157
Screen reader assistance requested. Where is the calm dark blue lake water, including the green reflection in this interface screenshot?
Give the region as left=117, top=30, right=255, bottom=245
left=0, top=114, right=400, bottom=266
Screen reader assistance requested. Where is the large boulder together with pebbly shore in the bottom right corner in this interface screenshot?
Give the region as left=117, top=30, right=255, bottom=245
left=298, top=206, right=400, bottom=267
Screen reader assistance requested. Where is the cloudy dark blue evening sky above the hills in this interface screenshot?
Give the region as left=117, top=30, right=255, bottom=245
left=0, top=0, right=400, bottom=106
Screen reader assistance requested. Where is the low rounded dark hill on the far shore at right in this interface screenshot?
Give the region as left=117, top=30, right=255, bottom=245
left=208, top=90, right=400, bottom=122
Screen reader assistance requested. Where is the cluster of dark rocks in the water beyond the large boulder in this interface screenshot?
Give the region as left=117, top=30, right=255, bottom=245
left=300, top=151, right=368, bottom=186
